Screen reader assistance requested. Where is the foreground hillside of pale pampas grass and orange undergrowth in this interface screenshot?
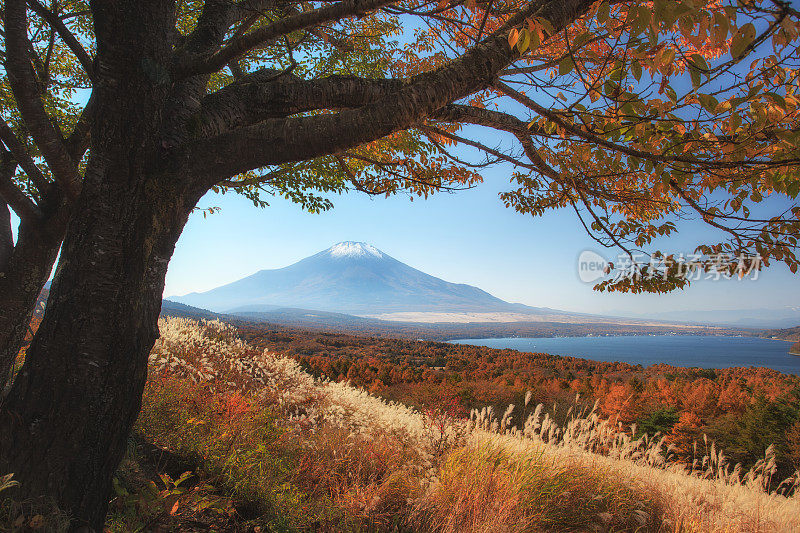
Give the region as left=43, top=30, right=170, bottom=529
left=0, top=318, right=800, bottom=533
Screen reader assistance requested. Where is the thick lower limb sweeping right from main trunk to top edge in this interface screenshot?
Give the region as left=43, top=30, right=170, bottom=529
left=187, top=0, right=591, bottom=186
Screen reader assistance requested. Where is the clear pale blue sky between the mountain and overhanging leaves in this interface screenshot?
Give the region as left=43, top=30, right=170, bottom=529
left=164, top=158, right=800, bottom=314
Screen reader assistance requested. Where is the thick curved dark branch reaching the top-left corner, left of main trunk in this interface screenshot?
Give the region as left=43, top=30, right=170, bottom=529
left=5, top=0, right=80, bottom=198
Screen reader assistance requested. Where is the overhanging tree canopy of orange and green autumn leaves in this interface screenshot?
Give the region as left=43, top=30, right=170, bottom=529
left=0, top=0, right=800, bottom=291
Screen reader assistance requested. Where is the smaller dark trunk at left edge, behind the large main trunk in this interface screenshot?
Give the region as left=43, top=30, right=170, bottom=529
left=0, top=207, right=67, bottom=386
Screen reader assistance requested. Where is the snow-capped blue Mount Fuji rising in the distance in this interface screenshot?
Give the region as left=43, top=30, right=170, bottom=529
left=170, top=241, right=544, bottom=315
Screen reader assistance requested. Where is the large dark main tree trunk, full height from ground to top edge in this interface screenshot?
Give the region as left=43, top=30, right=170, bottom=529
left=0, top=4, right=204, bottom=531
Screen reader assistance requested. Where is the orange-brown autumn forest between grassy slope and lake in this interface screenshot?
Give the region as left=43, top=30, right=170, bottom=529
left=240, top=324, right=800, bottom=471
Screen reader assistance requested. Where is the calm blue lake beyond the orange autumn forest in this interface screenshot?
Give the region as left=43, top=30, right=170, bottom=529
left=450, top=335, right=800, bottom=375
